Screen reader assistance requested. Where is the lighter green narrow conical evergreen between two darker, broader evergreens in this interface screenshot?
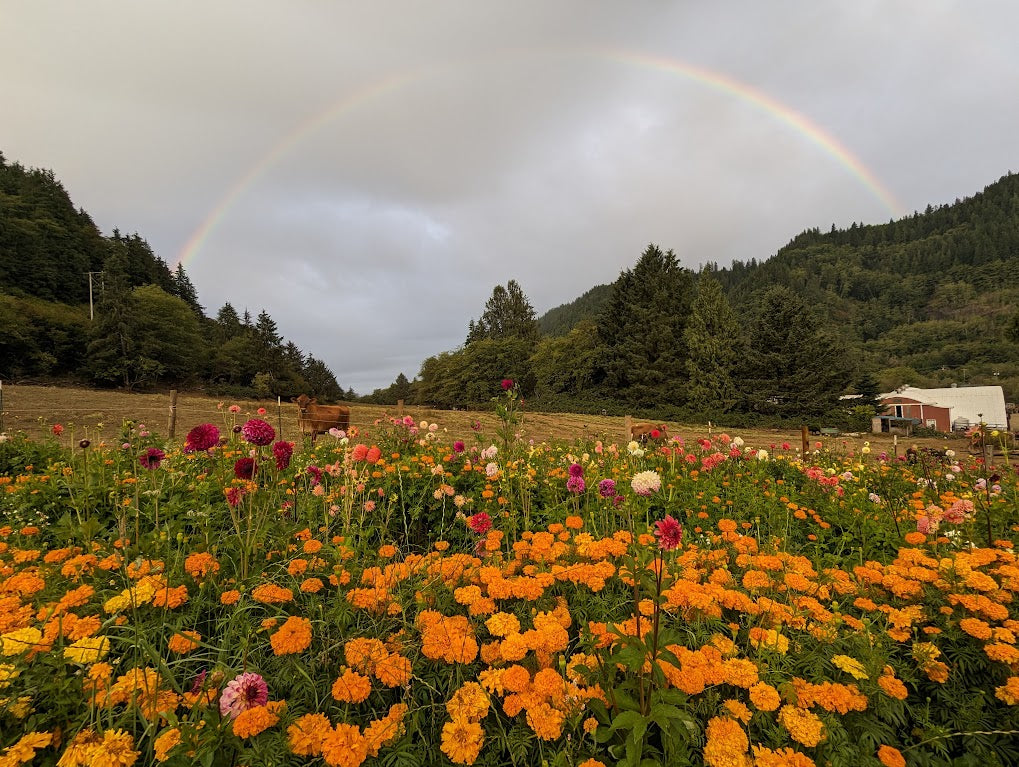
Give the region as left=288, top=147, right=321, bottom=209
left=683, top=275, right=743, bottom=414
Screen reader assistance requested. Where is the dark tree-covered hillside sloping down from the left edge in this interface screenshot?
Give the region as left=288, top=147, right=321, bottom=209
left=0, top=154, right=353, bottom=400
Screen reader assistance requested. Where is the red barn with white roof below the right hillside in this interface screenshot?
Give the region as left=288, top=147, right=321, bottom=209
left=880, top=386, right=1008, bottom=432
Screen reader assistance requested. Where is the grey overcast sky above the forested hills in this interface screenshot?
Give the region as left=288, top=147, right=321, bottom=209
left=0, top=0, right=1019, bottom=393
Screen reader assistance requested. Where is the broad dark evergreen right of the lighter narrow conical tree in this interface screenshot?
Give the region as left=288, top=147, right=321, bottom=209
left=742, top=286, right=850, bottom=418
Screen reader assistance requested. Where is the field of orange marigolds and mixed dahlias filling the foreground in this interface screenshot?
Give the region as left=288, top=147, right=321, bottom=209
left=0, top=391, right=1019, bottom=767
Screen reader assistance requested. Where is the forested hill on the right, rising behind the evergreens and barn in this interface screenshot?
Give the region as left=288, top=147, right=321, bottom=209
left=539, top=173, right=1019, bottom=396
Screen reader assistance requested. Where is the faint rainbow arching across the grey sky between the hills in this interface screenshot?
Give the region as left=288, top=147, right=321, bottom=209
left=177, top=49, right=904, bottom=267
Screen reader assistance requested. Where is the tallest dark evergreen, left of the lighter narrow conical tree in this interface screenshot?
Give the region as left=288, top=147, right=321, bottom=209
left=598, top=244, right=693, bottom=407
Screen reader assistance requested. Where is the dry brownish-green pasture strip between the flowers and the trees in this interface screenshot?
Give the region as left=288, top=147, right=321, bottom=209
left=2, top=384, right=966, bottom=453
